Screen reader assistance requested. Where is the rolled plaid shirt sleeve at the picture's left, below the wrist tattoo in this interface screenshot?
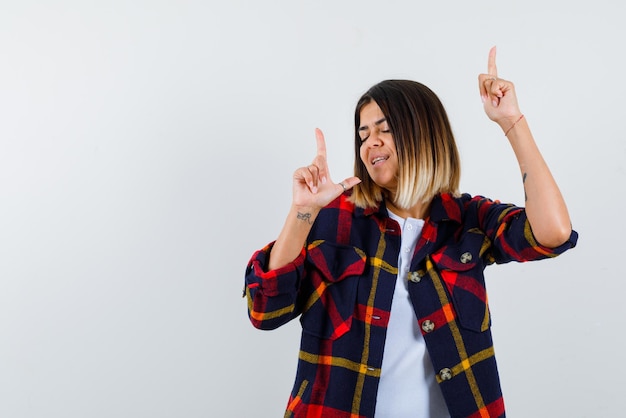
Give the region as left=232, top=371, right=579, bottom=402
left=244, top=242, right=305, bottom=330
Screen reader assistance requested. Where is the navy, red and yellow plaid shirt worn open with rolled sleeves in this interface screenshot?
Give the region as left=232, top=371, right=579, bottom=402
left=245, top=194, right=578, bottom=418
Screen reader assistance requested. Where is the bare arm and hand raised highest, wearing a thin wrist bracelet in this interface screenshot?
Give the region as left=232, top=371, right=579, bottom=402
left=478, top=47, right=572, bottom=248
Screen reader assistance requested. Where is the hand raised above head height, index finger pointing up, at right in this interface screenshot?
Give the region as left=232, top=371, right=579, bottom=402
left=478, top=46, right=522, bottom=130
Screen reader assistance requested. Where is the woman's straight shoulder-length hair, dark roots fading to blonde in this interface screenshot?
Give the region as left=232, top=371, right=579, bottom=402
left=350, top=80, right=461, bottom=209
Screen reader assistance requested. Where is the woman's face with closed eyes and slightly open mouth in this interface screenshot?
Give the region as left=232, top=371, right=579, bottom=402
left=359, top=100, right=398, bottom=191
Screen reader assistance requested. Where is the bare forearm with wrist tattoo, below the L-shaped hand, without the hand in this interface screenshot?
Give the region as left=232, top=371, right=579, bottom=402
left=268, top=206, right=319, bottom=270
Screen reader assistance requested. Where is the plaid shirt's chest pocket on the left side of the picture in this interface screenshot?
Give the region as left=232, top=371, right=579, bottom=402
left=300, top=241, right=366, bottom=339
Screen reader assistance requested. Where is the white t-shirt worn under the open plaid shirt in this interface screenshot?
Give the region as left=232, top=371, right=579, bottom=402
left=375, top=211, right=450, bottom=418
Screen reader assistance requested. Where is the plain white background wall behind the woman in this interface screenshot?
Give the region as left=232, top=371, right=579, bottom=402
left=0, top=0, right=626, bottom=418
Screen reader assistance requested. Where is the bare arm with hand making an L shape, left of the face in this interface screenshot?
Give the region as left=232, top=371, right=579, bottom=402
left=268, top=129, right=361, bottom=270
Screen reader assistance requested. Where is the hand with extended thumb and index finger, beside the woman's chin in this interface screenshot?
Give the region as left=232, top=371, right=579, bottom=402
left=293, top=129, right=361, bottom=211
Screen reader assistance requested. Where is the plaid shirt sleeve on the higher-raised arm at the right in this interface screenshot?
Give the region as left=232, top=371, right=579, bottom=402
left=472, top=197, right=578, bottom=264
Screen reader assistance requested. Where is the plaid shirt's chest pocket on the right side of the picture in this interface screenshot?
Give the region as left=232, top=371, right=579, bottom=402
left=432, top=229, right=491, bottom=332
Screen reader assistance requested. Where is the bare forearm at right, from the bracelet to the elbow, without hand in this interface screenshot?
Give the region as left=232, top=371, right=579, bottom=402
left=502, top=118, right=571, bottom=247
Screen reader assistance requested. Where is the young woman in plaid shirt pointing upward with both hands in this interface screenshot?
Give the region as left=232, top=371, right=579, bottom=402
left=245, top=49, right=577, bottom=418
